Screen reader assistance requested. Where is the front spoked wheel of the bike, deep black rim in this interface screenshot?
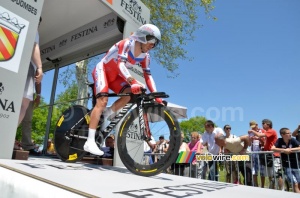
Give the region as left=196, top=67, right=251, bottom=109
left=117, top=106, right=180, bottom=176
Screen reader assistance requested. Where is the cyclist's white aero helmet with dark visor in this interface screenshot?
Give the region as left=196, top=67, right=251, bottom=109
left=132, top=24, right=161, bottom=47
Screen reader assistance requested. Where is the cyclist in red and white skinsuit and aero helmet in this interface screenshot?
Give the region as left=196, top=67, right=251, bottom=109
left=84, top=24, right=162, bottom=155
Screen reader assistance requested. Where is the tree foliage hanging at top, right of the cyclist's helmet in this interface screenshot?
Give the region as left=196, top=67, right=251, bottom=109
left=142, top=0, right=216, bottom=77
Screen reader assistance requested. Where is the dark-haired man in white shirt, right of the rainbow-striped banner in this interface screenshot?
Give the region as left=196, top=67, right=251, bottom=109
left=200, top=120, right=225, bottom=181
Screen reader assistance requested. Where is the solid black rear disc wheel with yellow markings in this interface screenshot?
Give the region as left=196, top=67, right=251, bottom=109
left=54, top=105, right=90, bottom=162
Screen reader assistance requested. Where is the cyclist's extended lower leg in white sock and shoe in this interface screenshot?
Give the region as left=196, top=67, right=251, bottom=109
left=83, top=97, right=108, bottom=155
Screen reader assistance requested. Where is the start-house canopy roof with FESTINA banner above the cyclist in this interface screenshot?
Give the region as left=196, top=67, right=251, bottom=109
left=39, top=0, right=150, bottom=71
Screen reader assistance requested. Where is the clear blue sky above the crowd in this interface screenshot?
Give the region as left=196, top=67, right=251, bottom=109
left=42, top=0, right=300, bottom=138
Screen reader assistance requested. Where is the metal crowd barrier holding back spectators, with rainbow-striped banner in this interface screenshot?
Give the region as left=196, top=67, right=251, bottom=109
left=145, top=151, right=300, bottom=192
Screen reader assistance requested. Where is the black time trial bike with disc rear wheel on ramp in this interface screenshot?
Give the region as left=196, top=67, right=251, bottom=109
left=54, top=84, right=181, bottom=176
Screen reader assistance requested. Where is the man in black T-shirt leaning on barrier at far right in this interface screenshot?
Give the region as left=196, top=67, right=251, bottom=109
left=271, top=128, right=300, bottom=193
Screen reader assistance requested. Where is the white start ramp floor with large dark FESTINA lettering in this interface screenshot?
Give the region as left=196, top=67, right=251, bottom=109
left=0, top=158, right=299, bottom=198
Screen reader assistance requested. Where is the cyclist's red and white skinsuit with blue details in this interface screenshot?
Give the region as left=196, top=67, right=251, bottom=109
left=92, top=38, right=156, bottom=96
